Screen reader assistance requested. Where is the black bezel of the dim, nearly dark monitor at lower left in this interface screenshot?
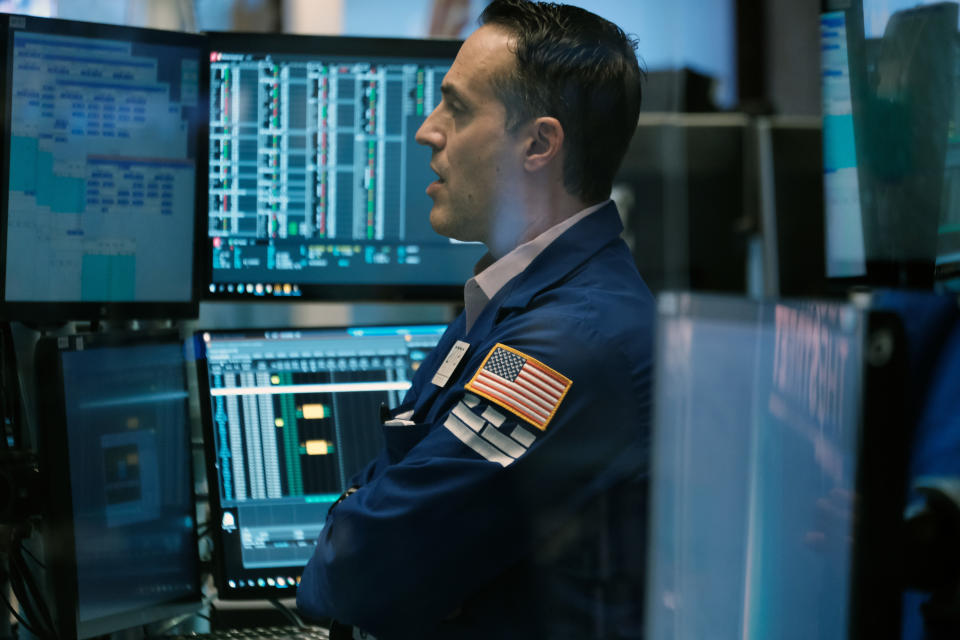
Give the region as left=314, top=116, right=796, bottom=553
left=35, top=330, right=203, bottom=639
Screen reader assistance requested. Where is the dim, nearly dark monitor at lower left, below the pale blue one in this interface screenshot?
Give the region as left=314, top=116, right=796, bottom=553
left=36, top=333, right=202, bottom=638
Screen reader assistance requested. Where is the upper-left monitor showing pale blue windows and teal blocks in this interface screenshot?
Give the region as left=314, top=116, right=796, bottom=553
left=0, top=15, right=209, bottom=321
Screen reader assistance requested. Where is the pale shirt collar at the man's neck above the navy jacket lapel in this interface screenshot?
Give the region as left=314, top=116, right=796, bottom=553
left=463, top=200, right=610, bottom=331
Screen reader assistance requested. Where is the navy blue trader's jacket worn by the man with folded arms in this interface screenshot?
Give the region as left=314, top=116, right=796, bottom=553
left=297, top=203, right=653, bottom=640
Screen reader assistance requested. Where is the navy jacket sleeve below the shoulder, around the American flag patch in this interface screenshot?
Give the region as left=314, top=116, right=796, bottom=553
left=297, top=314, right=650, bottom=637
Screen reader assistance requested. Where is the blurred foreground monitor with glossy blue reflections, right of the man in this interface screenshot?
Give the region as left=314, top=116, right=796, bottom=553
left=645, top=292, right=909, bottom=640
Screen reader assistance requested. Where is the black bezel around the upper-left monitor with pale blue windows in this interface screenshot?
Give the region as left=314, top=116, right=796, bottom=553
left=0, top=14, right=210, bottom=324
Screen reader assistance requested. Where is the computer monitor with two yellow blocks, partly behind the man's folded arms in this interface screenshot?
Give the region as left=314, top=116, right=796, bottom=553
left=194, top=325, right=445, bottom=599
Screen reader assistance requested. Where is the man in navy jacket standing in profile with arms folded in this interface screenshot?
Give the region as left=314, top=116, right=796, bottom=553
left=297, top=0, right=653, bottom=640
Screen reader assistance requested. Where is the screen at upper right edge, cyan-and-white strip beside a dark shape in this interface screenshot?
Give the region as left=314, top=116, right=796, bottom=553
left=821, top=0, right=960, bottom=290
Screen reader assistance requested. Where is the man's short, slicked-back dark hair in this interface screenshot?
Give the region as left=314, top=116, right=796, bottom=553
left=480, top=0, right=643, bottom=203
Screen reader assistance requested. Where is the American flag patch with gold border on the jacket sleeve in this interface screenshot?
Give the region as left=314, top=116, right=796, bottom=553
left=466, top=343, right=572, bottom=431
